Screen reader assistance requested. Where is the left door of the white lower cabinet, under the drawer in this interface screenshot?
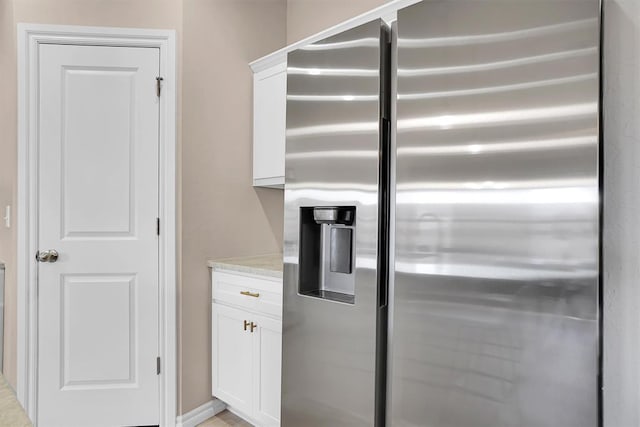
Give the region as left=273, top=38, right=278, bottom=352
left=211, top=303, right=255, bottom=413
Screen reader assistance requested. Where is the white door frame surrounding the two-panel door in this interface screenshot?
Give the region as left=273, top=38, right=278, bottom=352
left=16, top=24, right=177, bottom=427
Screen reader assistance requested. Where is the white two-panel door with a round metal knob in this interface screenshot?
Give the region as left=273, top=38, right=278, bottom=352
left=37, top=45, right=160, bottom=427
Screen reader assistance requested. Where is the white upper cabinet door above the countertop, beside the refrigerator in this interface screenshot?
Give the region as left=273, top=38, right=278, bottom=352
left=253, top=63, right=287, bottom=187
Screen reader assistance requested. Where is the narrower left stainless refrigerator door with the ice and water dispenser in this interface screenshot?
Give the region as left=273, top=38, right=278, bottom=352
left=282, top=21, right=386, bottom=427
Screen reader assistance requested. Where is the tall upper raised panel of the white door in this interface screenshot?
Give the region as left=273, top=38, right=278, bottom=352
left=60, top=67, right=137, bottom=238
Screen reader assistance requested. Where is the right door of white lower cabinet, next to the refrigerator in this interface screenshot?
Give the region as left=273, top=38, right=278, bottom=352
left=253, top=316, right=282, bottom=427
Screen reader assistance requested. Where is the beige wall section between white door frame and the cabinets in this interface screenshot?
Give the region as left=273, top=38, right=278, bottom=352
left=180, top=0, right=286, bottom=413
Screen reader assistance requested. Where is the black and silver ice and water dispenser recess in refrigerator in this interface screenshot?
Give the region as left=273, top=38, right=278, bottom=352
left=298, top=206, right=356, bottom=304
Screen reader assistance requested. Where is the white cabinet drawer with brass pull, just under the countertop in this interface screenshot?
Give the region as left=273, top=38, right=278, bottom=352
left=212, top=271, right=282, bottom=317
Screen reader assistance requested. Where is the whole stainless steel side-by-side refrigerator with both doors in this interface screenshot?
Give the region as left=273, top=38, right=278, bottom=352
left=282, top=0, right=601, bottom=427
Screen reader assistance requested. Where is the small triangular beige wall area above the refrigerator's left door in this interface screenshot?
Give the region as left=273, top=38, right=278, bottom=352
left=287, top=0, right=390, bottom=44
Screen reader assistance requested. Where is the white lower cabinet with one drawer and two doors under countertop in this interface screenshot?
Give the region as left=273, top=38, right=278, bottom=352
left=211, top=271, right=282, bottom=427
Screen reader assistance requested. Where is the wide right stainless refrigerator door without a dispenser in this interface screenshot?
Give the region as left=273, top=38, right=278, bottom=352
left=387, top=0, right=600, bottom=427
